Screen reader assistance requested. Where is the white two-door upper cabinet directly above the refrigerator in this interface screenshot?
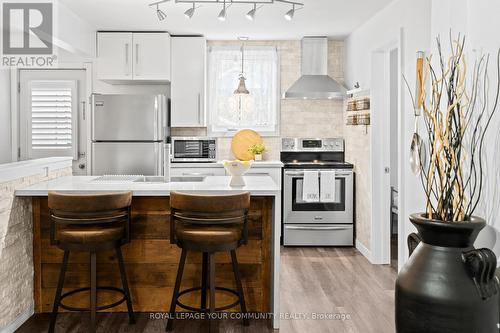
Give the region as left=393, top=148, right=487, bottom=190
left=97, top=32, right=171, bottom=83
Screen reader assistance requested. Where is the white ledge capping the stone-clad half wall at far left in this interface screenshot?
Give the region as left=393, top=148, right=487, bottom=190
left=0, top=157, right=72, bottom=183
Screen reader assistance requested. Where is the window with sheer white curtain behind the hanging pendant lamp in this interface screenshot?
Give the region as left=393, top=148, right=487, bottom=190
left=208, top=46, right=280, bottom=136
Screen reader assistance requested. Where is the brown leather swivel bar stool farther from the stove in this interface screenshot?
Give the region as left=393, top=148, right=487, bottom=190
left=48, top=192, right=135, bottom=333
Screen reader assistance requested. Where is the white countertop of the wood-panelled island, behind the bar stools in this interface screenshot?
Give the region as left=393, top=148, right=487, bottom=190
left=16, top=176, right=281, bottom=197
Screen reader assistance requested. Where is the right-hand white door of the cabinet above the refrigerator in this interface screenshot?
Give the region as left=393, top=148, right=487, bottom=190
left=133, top=32, right=170, bottom=81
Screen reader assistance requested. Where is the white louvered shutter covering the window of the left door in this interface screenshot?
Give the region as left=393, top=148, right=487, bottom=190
left=27, top=81, right=78, bottom=159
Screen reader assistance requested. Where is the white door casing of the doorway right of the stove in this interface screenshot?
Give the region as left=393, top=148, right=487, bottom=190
left=368, top=28, right=405, bottom=268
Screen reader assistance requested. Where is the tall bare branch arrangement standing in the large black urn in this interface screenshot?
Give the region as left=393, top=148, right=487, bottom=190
left=410, top=36, right=500, bottom=222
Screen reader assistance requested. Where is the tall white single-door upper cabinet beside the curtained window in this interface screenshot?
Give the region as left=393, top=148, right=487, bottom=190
left=171, top=37, right=206, bottom=127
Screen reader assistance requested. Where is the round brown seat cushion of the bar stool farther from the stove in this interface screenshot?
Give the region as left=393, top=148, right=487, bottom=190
left=57, top=223, right=125, bottom=244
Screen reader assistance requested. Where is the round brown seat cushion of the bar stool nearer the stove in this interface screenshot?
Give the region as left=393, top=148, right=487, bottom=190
left=175, top=223, right=242, bottom=245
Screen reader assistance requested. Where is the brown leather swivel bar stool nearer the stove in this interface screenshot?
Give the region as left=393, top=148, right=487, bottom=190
left=166, top=192, right=250, bottom=331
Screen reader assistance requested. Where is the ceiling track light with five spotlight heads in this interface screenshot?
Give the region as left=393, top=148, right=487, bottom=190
left=149, top=0, right=304, bottom=21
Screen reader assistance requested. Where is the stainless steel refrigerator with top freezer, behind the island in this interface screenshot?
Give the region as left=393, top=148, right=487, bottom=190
left=92, top=94, right=170, bottom=176
